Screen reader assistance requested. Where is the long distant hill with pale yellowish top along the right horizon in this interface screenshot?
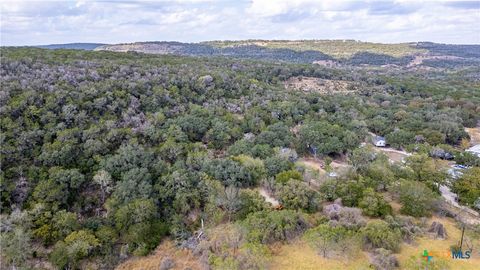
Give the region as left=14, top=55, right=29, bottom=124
left=95, top=40, right=480, bottom=67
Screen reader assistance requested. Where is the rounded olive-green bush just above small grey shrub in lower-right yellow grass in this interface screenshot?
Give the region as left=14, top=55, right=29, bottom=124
left=360, top=220, right=402, bottom=252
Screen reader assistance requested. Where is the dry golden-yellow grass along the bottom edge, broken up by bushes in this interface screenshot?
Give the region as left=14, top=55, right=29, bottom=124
left=117, top=217, right=480, bottom=270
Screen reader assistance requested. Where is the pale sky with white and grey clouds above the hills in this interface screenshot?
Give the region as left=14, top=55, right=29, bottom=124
left=0, top=0, right=480, bottom=46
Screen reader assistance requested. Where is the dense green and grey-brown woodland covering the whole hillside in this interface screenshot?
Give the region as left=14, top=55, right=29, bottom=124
left=0, top=47, right=480, bottom=269
